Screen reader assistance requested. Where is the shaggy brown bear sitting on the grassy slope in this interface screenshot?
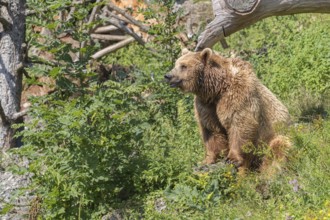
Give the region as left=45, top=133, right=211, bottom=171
left=165, top=48, right=290, bottom=169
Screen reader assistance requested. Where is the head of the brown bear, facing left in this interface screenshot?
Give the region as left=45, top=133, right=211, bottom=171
left=165, top=48, right=218, bottom=93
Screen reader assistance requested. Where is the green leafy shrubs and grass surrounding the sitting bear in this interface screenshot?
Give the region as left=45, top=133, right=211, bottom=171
left=1, top=0, right=330, bottom=219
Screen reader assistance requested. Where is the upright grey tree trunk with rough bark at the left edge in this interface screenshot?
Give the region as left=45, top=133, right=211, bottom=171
left=0, top=0, right=25, bottom=150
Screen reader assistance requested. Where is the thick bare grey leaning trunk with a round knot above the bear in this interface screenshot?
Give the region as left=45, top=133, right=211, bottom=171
left=195, top=0, right=330, bottom=51
